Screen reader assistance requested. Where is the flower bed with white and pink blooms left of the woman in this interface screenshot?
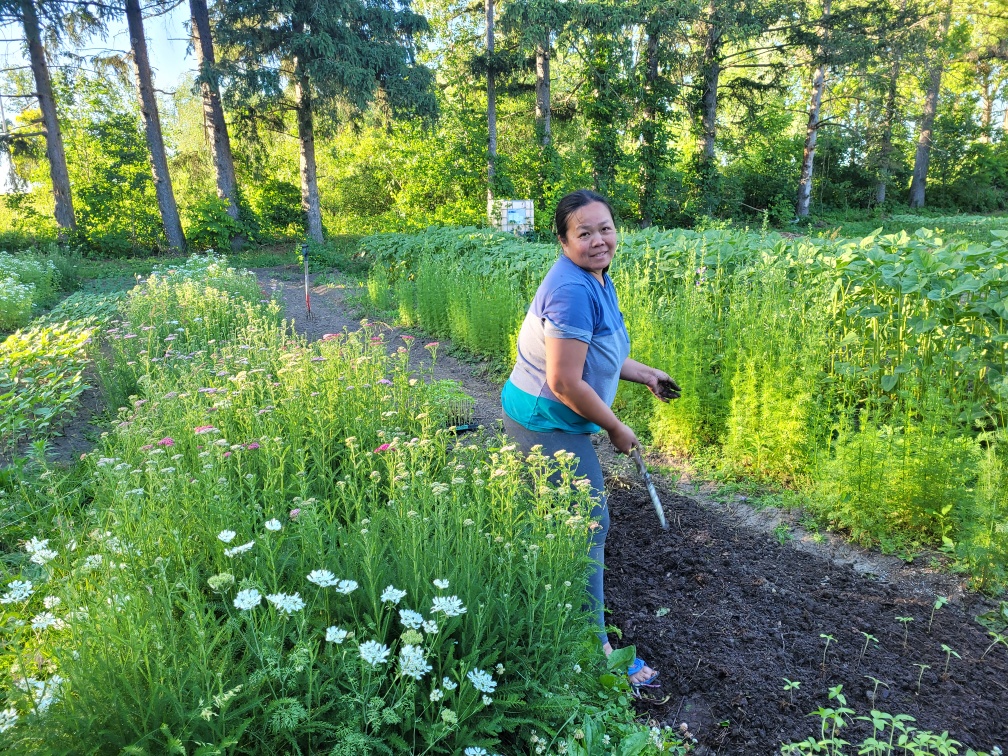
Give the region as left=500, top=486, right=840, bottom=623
left=0, top=258, right=661, bottom=754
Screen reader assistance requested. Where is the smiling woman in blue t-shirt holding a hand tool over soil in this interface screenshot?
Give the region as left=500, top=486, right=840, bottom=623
left=501, top=190, right=678, bottom=686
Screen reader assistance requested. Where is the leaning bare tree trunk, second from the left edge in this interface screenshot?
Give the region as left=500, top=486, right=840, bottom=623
left=126, top=0, right=185, bottom=252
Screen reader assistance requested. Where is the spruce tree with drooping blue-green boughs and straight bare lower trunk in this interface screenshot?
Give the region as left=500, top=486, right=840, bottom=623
left=214, top=0, right=436, bottom=242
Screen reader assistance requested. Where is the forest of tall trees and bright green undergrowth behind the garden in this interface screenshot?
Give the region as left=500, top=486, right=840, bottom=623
left=0, top=0, right=1008, bottom=255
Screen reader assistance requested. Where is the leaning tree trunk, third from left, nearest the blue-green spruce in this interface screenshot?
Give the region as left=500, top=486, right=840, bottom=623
left=190, top=0, right=238, bottom=221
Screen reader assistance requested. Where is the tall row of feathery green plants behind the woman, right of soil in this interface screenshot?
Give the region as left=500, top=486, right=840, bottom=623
left=361, top=229, right=1008, bottom=589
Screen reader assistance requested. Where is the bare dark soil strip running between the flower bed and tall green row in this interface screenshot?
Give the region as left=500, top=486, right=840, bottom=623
left=256, top=269, right=1008, bottom=754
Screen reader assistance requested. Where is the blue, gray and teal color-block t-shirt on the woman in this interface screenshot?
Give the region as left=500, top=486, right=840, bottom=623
left=501, top=255, right=630, bottom=433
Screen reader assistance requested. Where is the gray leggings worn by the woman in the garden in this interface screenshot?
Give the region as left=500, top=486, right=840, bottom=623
left=504, top=414, right=609, bottom=645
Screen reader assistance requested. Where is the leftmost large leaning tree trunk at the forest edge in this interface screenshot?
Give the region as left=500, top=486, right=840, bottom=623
left=21, top=0, right=77, bottom=233
